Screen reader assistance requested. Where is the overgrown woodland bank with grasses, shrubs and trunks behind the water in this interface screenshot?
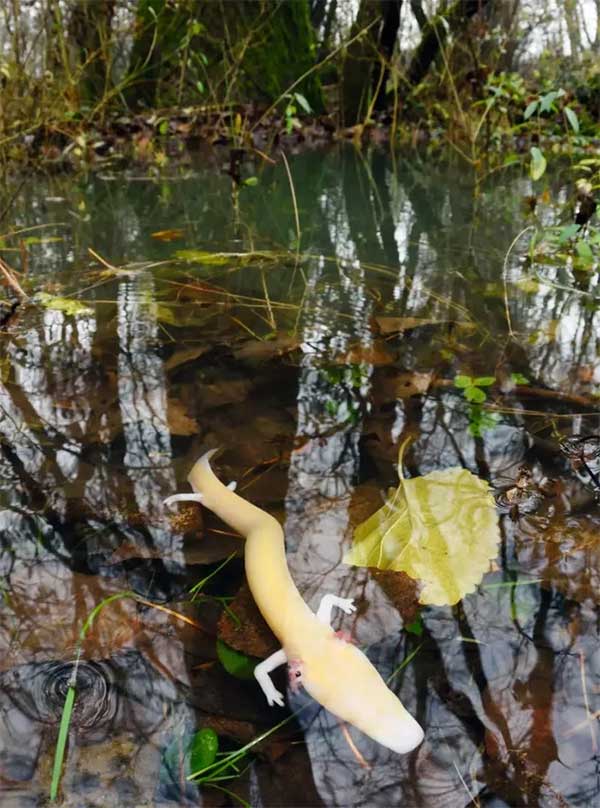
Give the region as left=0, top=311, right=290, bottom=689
left=0, top=0, right=600, bottom=172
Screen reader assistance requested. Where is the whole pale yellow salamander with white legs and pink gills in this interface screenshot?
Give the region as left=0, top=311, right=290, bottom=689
left=165, top=450, right=423, bottom=752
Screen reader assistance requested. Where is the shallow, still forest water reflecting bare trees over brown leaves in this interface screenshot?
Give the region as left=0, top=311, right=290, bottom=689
left=0, top=149, right=600, bottom=808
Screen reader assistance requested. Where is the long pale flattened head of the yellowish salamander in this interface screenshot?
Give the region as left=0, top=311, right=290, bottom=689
left=301, top=636, right=423, bottom=754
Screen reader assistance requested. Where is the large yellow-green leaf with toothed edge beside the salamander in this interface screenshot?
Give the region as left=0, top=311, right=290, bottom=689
left=344, top=460, right=500, bottom=606
